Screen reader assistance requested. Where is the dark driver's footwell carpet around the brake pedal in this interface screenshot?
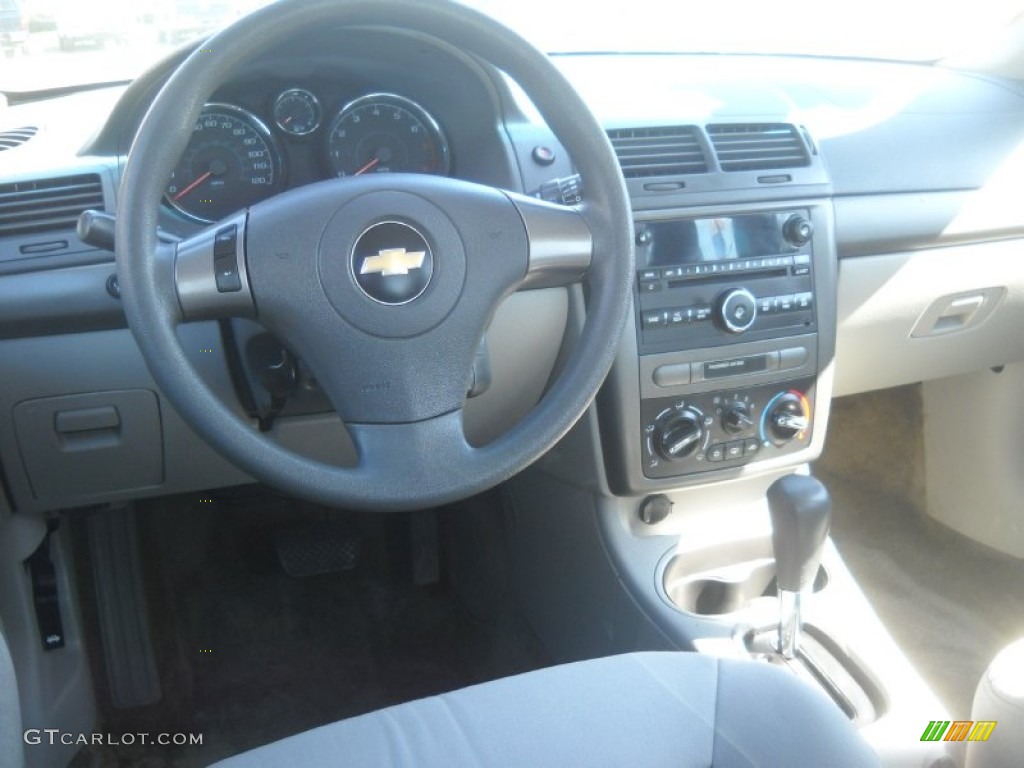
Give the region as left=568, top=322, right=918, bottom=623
left=76, top=495, right=548, bottom=768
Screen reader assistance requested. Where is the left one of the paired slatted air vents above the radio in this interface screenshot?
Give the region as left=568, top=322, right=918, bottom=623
left=608, top=125, right=708, bottom=178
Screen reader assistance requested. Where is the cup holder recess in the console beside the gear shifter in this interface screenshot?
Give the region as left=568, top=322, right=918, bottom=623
left=664, top=543, right=828, bottom=615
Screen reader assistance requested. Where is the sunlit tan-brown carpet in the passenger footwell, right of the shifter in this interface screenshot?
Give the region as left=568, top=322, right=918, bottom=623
left=814, top=387, right=1024, bottom=719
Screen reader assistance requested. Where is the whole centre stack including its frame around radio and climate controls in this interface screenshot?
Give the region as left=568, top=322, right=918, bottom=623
left=602, top=201, right=836, bottom=494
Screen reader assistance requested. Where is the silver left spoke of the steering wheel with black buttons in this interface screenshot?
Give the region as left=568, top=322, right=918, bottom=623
left=173, top=212, right=255, bottom=321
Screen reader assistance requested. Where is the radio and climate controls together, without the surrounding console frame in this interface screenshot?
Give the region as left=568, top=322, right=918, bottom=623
left=634, top=209, right=817, bottom=479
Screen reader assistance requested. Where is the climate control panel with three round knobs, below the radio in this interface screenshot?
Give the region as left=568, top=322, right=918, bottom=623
left=640, top=379, right=814, bottom=478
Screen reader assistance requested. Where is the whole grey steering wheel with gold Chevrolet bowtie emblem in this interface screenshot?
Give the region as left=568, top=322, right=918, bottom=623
left=116, top=0, right=633, bottom=518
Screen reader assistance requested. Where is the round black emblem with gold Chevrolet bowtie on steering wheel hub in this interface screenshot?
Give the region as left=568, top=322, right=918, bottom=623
left=350, top=221, right=434, bottom=306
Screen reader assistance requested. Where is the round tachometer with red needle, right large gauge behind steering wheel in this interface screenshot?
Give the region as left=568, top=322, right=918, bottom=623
left=328, top=93, right=449, bottom=176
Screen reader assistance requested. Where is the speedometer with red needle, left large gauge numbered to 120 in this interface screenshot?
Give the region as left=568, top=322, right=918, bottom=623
left=166, top=103, right=283, bottom=222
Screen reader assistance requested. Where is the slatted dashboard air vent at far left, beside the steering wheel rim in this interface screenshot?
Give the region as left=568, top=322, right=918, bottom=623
left=0, top=173, right=103, bottom=237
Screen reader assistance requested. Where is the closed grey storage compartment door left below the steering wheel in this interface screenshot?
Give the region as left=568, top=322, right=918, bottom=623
left=13, top=389, right=164, bottom=503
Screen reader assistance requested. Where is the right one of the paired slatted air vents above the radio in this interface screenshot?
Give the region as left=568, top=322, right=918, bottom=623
left=708, top=123, right=811, bottom=171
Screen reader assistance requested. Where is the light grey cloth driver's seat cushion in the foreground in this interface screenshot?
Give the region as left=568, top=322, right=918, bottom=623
left=209, top=653, right=880, bottom=768
